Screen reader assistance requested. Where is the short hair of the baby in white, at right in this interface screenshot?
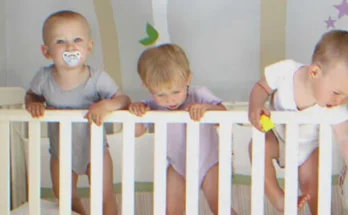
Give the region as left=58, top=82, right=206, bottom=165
left=312, top=30, right=348, bottom=67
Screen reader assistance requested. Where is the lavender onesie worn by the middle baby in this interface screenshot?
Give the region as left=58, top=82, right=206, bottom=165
left=144, top=87, right=222, bottom=185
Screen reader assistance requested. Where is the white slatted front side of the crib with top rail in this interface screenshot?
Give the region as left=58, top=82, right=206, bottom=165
left=0, top=110, right=338, bottom=215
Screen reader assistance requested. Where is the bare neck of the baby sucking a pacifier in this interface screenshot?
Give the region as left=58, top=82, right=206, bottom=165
left=52, top=65, right=89, bottom=90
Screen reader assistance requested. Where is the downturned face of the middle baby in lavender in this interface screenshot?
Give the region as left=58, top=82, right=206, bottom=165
left=150, top=84, right=187, bottom=110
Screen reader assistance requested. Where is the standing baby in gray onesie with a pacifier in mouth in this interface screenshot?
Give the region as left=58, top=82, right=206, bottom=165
left=25, top=11, right=130, bottom=215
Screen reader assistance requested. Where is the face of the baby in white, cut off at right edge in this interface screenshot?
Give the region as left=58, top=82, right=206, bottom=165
left=313, top=64, right=348, bottom=107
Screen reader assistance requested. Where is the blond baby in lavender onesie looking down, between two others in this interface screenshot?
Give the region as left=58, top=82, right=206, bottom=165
left=129, top=44, right=235, bottom=214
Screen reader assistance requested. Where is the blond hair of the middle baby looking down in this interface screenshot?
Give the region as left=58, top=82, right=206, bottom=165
left=138, top=44, right=191, bottom=89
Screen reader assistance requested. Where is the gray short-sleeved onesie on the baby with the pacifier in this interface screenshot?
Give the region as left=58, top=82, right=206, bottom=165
left=30, top=66, right=119, bottom=175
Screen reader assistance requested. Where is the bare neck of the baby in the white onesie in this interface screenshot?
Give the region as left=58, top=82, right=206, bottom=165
left=294, top=66, right=316, bottom=110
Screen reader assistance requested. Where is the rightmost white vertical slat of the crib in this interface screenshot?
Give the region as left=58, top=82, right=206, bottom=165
left=318, top=124, right=332, bottom=215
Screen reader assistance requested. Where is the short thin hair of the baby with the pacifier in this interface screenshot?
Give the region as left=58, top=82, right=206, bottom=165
left=42, top=10, right=91, bottom=43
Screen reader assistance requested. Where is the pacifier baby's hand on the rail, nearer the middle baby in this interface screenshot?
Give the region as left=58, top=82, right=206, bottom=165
left=84, top=100, right=110, bottom=126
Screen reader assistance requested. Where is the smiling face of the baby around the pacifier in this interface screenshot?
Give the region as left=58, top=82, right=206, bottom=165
left=44, top=18, right=93, bottom=68
